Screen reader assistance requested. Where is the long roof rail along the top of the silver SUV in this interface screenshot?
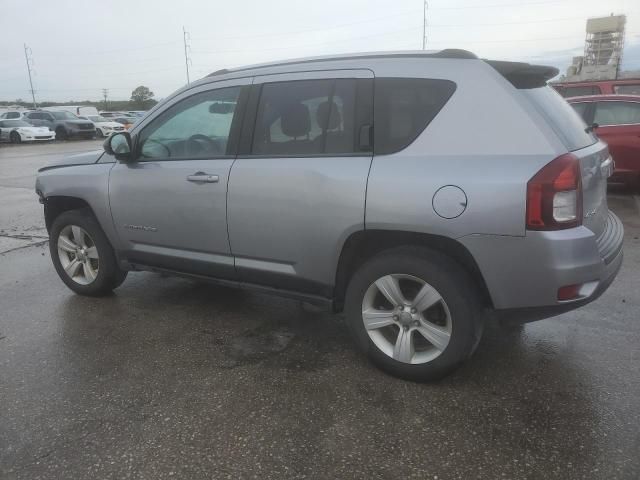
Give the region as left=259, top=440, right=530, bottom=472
left=207, top=48, right=478, bottom=77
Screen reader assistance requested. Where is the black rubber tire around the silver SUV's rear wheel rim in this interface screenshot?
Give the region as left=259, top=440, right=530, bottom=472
left=345, top=247, right=484, bottom=381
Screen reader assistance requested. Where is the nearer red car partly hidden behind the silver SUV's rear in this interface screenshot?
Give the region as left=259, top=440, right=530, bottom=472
left=567, top=95, right=640, bottom=187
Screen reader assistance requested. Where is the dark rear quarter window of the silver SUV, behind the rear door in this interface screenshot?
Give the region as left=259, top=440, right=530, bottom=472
left=373, top=78, right=456, bottom=155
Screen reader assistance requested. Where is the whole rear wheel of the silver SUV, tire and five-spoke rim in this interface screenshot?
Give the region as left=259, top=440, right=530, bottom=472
left=345, top=247, right=483, bottom=381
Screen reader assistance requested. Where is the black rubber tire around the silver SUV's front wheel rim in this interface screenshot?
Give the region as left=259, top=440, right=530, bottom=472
left=49, top=209, right=127, bottom=297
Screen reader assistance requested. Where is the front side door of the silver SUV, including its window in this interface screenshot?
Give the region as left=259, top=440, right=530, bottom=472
left=109, top=79, right=250, bottom=278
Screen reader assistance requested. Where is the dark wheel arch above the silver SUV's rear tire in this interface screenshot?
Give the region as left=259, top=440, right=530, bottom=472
left=333, top=230, right=493, bottom=311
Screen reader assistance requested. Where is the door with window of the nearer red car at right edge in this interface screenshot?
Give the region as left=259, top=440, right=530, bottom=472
left=593, top=100, right=640, bottom=178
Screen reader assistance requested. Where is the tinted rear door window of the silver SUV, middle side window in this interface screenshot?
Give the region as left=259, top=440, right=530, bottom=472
left=252, top=79, right=356, bottom=156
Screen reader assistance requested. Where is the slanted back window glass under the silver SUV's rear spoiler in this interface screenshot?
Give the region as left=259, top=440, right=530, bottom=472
left=520, top=87, right=597, bottom=150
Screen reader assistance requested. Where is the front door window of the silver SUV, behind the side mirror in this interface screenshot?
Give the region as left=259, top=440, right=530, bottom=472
left=139, top=87, right=242, bottom=160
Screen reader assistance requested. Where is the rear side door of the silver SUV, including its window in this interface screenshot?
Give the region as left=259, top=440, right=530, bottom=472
left=228, top=70, right=373, bottom=297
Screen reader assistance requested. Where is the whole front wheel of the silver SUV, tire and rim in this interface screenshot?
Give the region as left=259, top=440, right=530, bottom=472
left=49, top=210, right=127, bottom=296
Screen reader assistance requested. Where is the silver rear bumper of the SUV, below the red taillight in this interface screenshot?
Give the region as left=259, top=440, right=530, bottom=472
left=459, top=212, right=624, bottom=321
